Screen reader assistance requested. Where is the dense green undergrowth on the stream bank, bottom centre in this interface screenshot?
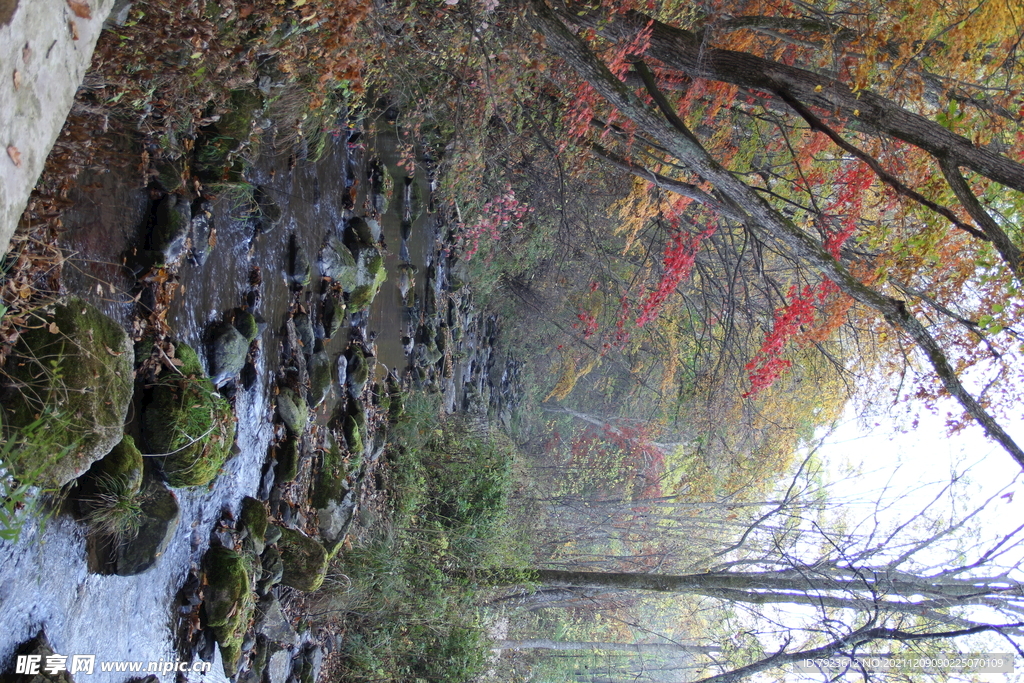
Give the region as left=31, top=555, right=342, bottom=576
left=309, top=395, right=528, bottom=682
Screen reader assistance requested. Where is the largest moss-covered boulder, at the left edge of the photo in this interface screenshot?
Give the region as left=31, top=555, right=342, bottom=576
left=5, top=298, right=134, bottom=486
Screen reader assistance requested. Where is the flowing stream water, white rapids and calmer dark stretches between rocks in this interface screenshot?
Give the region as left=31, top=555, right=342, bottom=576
left=0, top=124, right=434, bottom=683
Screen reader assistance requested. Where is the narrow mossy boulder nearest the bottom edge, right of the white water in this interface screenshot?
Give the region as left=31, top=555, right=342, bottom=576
left=203, top=547, right=259, bottom=676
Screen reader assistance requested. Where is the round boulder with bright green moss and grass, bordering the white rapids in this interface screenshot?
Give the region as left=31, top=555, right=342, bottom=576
left=142, top=344, right=234, bottom=486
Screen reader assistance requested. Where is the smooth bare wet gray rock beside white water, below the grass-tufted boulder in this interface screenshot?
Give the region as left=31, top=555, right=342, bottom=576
left=115, top=480, right=180, bottom=577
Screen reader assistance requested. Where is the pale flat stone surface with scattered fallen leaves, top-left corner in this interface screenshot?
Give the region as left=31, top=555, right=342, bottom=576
left=0, top=0, right=114, bottom=254
